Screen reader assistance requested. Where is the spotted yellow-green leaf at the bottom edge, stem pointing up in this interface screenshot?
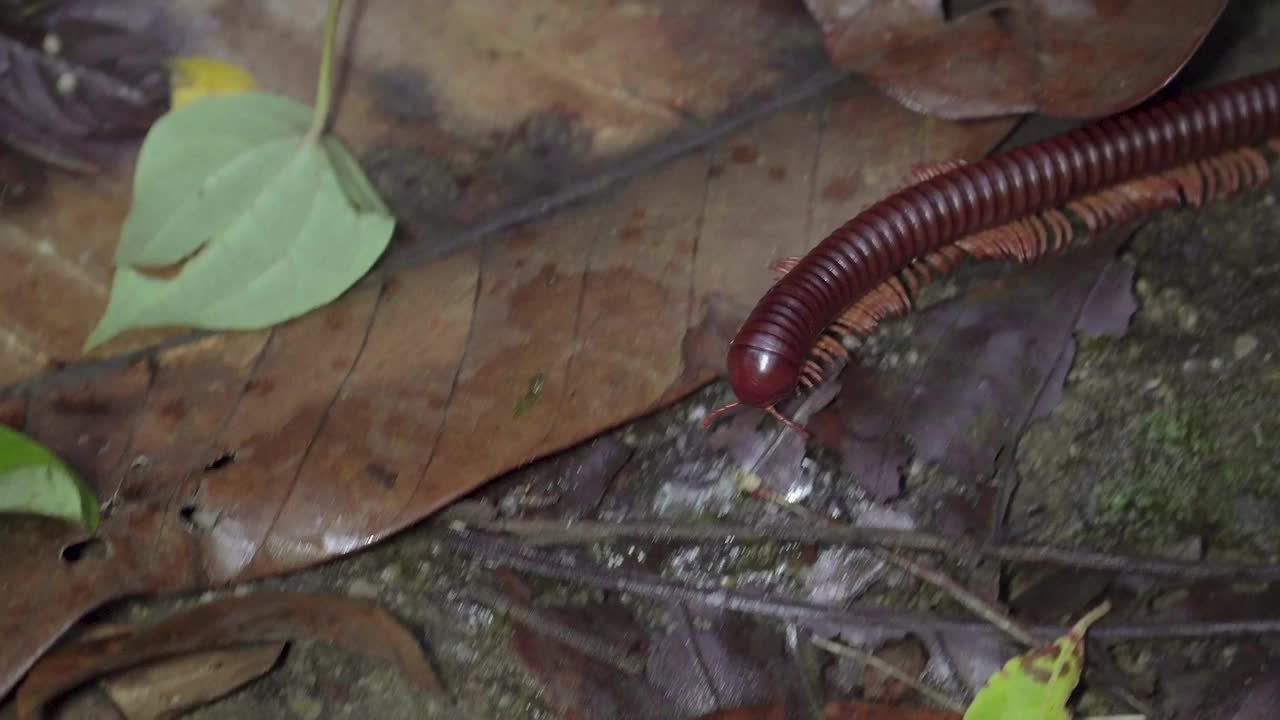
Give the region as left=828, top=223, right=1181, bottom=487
left=964, top=603, right=1111, bottom=720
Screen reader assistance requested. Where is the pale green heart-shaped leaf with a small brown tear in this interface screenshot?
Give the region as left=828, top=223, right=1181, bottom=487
left=86, top=92, right=396, bottom=350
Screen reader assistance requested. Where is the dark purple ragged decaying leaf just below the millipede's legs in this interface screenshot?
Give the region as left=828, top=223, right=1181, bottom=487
left=832, top=233, right=1137, bottom=498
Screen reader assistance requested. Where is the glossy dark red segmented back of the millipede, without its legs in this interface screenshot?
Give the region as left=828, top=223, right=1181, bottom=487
left=728, top=70, right=1280, bottom=406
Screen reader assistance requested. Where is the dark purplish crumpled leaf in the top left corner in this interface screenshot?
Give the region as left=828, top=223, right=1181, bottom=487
left=0, top=0, right=174, bottom=169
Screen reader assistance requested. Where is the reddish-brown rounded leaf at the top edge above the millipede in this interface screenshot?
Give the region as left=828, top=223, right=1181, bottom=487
left=805, top=0, right=1226, bottom=118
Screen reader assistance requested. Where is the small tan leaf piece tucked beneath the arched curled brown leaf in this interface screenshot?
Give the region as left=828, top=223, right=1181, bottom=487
left=102, top=642, right=285, bottom=720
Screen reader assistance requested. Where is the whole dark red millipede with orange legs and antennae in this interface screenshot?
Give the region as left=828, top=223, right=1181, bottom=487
left=707, top=70, right=1280, bottom=433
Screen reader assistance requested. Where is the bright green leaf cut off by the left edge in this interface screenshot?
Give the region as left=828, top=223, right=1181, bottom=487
left=0, top=425, right=99, bottom=532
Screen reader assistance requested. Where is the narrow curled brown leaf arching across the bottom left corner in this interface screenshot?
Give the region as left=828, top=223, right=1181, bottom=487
left=17, top=592, right=440, bottom=720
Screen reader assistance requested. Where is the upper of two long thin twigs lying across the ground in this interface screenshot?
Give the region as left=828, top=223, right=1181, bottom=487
left=456, top=520, right=1280, bottom=580
